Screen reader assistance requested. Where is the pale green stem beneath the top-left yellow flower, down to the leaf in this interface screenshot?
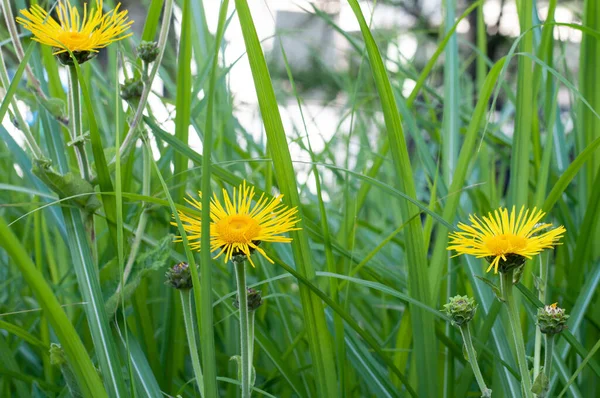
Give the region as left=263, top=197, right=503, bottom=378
left=69, top=65, right=90, bottom=181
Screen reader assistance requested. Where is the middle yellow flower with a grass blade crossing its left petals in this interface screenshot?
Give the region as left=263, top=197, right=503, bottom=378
left=171, top=181, right=300, bottom=266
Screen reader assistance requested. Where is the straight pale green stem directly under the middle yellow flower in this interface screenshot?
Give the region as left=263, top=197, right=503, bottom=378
left=233, top=261, right=252, bottom=398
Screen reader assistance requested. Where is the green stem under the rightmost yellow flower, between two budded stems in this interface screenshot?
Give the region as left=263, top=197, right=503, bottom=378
left=500, top=271, right=533, bottom=398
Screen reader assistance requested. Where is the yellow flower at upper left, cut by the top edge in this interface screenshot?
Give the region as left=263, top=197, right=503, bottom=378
left=17, top=0, right=133, bottom=54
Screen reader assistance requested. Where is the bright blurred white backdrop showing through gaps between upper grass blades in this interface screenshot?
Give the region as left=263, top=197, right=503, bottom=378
left=0, top=0, right=583, bottom=193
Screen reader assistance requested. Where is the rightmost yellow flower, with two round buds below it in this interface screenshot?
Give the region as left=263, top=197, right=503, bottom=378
left=448, top=206, right=566, bottom=273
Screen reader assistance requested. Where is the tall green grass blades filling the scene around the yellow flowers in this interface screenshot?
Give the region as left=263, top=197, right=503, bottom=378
left=0, top=0, right=600, bottom=398
